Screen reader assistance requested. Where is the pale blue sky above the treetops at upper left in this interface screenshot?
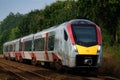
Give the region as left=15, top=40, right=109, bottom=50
left=0, top=0, right=56, bottom=21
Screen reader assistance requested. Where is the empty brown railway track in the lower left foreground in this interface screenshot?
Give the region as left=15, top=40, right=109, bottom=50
left=0, top=61, right=53, bottom=80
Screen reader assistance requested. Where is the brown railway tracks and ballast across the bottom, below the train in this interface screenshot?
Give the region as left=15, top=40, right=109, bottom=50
left=0, top=59, right=119, bottom=80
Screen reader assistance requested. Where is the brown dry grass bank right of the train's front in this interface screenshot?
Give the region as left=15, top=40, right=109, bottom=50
left=100, top=54, right=120, bottom=78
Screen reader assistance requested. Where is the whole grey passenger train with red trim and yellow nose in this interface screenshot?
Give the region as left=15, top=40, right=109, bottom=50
left=3, top=19, right=103, bottom=70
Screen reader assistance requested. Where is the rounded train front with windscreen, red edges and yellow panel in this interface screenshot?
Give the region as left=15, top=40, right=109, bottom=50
left=67, top=19, right=103, bottom=68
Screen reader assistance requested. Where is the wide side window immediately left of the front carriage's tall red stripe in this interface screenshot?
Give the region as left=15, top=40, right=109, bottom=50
left=34, top=38, right=45, bottom=51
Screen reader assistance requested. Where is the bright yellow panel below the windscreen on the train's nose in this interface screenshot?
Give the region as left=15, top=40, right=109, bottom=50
left=76, top=45, right=98, bottom=55
